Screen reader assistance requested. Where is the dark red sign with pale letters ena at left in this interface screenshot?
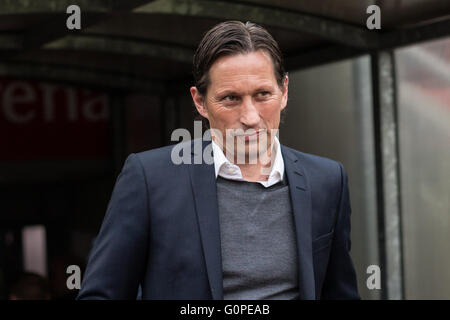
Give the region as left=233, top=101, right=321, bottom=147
left=0, top=79, right=109, bottom=161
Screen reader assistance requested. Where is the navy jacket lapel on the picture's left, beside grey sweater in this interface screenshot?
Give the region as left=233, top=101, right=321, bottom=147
left=188, top=139, right=223, bottom=300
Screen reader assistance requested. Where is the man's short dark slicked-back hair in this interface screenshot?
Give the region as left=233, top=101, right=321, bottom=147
left=192, top=21, right=287, bottom=128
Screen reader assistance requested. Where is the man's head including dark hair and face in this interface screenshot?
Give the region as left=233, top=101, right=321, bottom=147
left=191, top=21, right=288, bottom=160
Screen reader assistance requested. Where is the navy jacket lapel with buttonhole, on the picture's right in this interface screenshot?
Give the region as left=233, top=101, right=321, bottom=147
left=281, top=145, right=315, bottom=300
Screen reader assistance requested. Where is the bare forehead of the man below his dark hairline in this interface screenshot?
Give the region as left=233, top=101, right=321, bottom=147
left=209, top=50, right=276, bottom=87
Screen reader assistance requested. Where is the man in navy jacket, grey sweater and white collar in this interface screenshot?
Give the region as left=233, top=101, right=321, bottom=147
left=78, top=21, right=359, bottom=299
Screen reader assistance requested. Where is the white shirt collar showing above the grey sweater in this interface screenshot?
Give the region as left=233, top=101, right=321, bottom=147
left=212, top=136, right=284, bottom=188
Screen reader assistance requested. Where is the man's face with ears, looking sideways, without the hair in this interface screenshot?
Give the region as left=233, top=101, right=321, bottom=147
left=191, top=51, right=288, bottom=161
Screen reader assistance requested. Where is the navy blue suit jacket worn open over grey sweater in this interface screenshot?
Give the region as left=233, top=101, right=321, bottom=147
left=78, top=142, right=359, bottom=299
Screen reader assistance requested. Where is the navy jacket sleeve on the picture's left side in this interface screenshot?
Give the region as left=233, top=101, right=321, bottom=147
left=77, top=154, right=149, bottom=299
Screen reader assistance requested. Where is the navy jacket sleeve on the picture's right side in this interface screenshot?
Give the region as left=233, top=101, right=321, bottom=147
left=321, top=163, right=360, bottom=299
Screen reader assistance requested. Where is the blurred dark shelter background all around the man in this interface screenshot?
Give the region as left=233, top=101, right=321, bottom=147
left=0, top=0, right=450, bottom=299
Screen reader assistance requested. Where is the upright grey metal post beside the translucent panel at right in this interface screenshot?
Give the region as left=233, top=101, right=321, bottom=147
left=371, top=51, right=404, bottom=300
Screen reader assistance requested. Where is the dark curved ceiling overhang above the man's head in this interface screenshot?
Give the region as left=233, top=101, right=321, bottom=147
left=0, top=0, right=450, bottom=92
